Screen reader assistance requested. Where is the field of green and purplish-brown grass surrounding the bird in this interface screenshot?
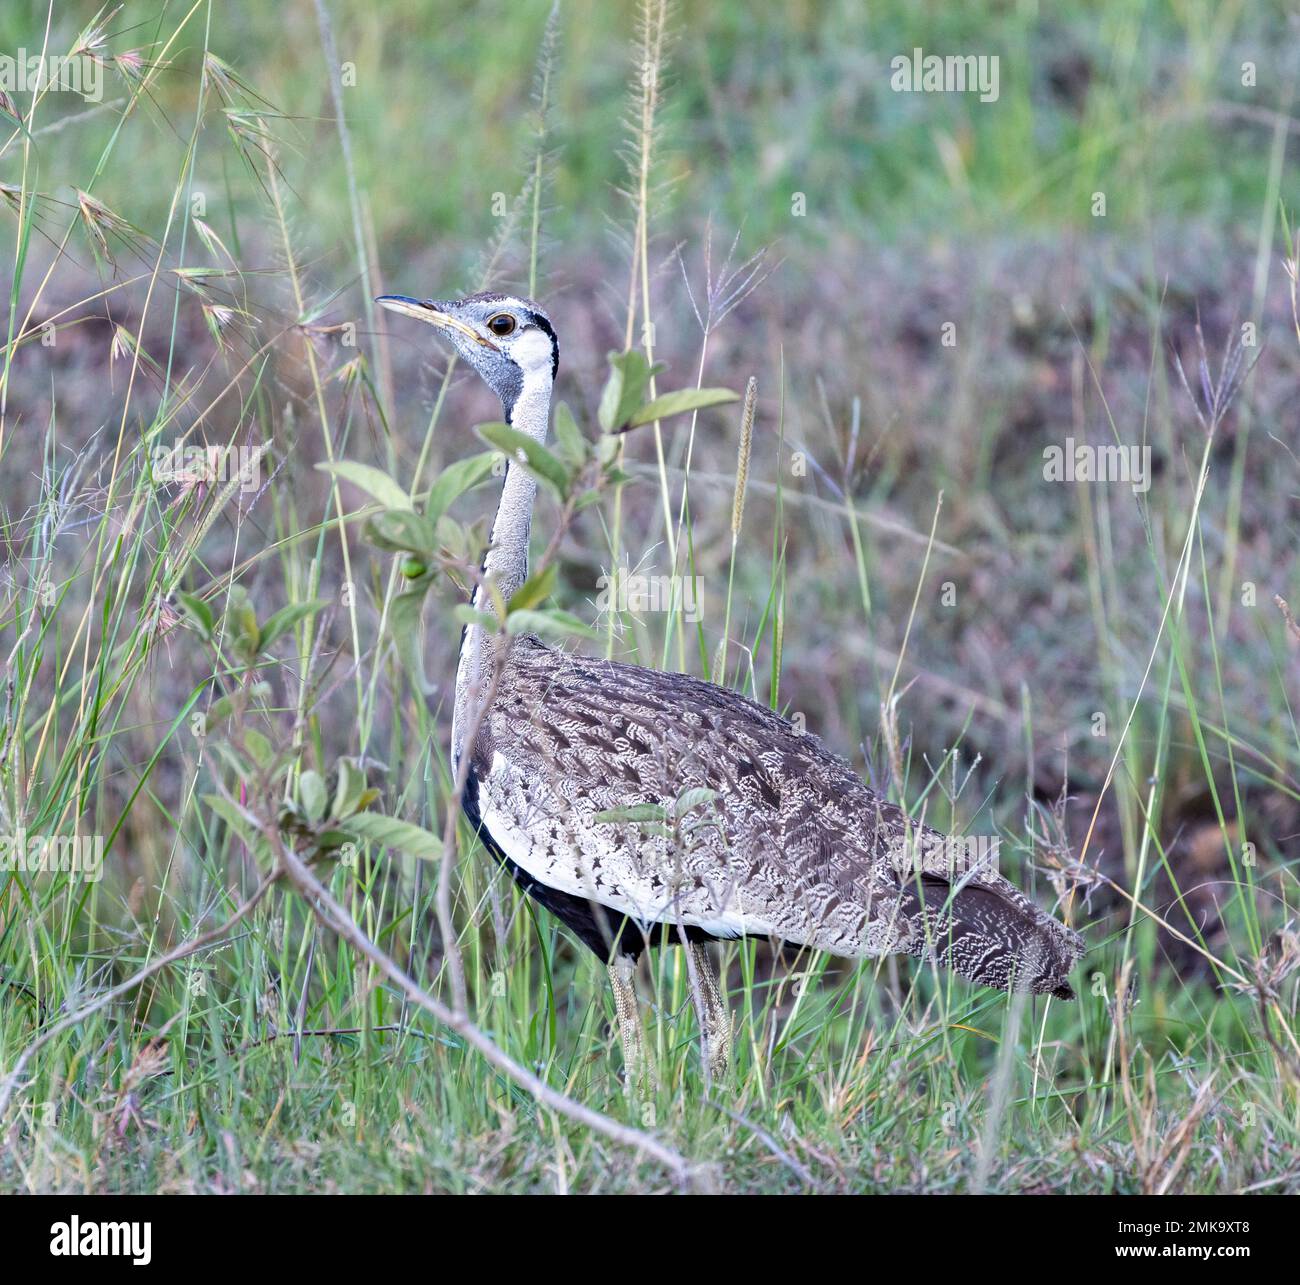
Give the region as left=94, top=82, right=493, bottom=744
left=0, top=0, right=1300, bottom=1191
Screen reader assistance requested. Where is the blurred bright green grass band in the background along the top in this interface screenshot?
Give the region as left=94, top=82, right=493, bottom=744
left=0, top=0, right=1295, bottom=241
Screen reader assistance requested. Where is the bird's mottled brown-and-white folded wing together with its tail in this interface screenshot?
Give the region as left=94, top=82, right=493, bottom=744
left=475, top=637, right=1074, bottom=990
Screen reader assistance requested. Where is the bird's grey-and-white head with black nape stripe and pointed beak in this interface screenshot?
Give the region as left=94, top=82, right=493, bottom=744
left=374, top=293, right=560, bottom=419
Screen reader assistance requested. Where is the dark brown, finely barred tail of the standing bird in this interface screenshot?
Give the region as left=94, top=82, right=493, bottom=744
left=900, top=871, right=1083, bottom=999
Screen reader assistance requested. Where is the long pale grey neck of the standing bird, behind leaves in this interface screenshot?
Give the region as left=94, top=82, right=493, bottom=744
left=451, top=371, right=551, bottom=770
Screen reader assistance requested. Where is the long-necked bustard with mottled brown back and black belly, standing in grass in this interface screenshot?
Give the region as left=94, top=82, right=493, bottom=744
left=378, top=294, right=1082, bottom=1080
